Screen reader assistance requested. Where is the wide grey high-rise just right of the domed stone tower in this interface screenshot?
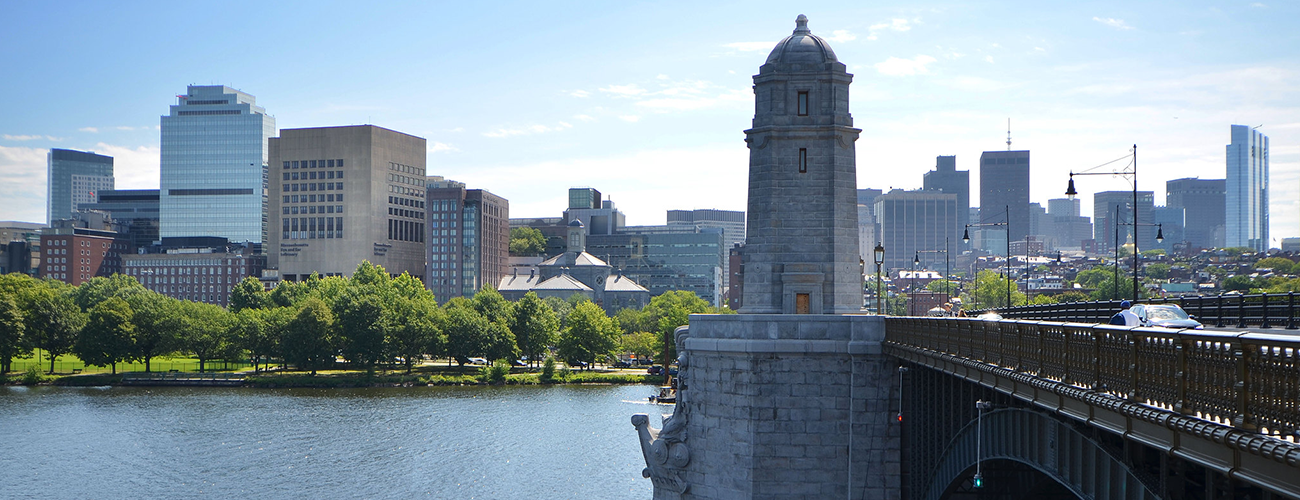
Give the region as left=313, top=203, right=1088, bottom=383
left=876, top=190, right=961, bottom=270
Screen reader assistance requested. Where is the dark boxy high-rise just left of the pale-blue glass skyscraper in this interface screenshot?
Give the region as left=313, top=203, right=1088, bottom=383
left=1165, top=178, right=1227, bottom=249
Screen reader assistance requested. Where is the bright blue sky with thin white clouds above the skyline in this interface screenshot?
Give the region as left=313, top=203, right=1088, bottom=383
left=0, top=0, right=1300, bottom=247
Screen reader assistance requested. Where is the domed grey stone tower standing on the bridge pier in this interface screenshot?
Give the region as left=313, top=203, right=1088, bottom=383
left=740, top=14, right=862, bottom=314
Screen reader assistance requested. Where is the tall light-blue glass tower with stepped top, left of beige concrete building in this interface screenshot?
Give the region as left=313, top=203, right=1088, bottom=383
left=159, top=86, right=276, bottom=245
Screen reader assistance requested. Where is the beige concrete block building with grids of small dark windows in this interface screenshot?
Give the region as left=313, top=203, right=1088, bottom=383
left=269, top=125, right=426, bottom=282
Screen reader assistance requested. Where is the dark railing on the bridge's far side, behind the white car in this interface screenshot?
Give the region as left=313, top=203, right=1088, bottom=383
left=982, top=292, right=1300, bottom=330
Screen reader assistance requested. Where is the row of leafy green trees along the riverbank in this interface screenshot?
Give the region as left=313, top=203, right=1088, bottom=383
left=0, top=261, right=727, bottom=374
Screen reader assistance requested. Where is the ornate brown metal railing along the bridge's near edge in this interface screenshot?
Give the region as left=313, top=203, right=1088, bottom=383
left=885, top=317, right=1300, bottom=442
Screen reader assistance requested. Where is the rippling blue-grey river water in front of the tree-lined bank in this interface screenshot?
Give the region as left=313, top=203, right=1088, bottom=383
left=0, top=386, right=660, bottom=493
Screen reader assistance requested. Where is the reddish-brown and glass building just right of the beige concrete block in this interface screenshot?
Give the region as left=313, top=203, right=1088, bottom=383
left=424, top=177, right=510, bottom=301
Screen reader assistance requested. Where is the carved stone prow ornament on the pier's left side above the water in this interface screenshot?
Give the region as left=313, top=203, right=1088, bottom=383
left=632, top=326, right=690, bottom=497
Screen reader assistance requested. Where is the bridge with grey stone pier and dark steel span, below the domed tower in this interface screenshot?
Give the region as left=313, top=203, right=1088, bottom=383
left=633, top=314, right=1300, bottom=500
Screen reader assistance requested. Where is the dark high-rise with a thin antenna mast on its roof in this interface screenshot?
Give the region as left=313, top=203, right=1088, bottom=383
left=979, top=151, right=1030, bottom=251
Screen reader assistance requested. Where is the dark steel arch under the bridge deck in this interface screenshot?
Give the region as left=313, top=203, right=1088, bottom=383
left=924, top=408, right=1160, bottom=500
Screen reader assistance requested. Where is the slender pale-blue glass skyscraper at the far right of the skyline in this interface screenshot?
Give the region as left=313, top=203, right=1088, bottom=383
left=1223, top=125, right=1269, bottom=252
